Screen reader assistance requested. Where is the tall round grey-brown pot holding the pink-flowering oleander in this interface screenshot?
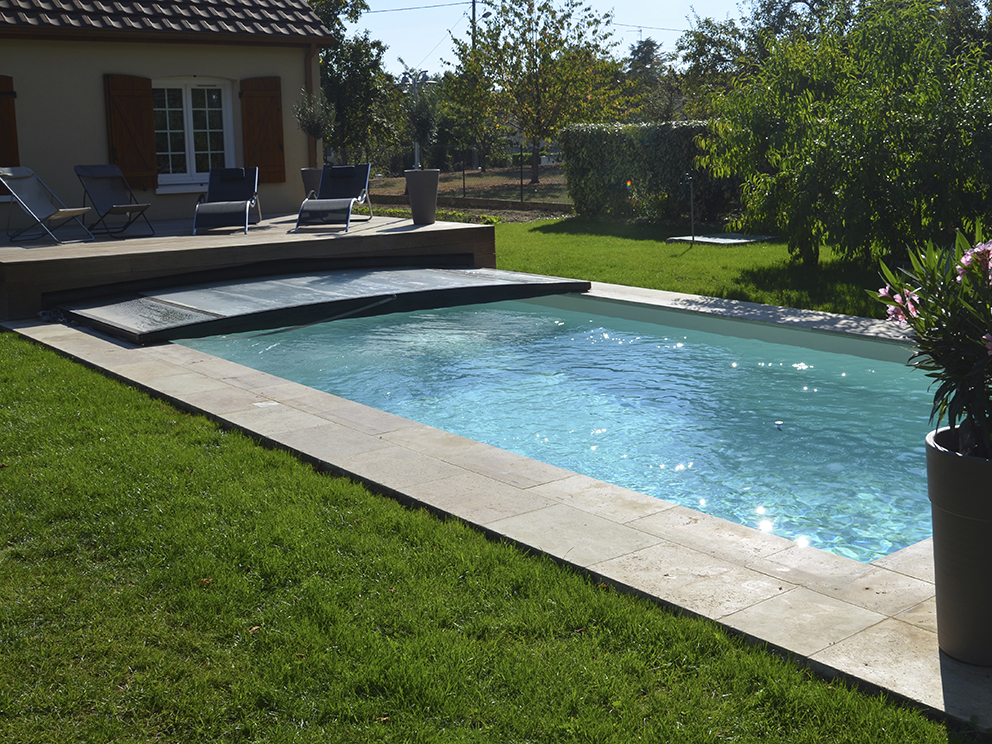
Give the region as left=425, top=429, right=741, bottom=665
left=927, top=428, right=992, bottom=666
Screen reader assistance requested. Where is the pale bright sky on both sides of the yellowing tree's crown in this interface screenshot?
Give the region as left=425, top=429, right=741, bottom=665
left=346, top=0, right=740, bottom=75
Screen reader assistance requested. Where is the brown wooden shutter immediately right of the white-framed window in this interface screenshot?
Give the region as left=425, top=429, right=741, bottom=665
left=240, top=77, right=286, bottom=183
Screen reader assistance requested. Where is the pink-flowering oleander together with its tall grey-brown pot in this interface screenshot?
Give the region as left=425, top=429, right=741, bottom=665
left=878, top=230, right=992, bottom=666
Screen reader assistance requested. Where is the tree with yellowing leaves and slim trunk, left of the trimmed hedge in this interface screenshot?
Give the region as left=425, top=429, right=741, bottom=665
left=455, top=0, right=627, bottom=183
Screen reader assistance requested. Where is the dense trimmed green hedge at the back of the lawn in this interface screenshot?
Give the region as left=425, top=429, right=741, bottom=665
left=556, top=122, right=737, bottom=221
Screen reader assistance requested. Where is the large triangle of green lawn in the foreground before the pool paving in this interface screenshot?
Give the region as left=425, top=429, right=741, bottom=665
left=0, top=333, right=971, bottom=744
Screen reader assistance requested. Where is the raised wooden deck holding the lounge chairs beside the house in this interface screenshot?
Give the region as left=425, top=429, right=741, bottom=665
left=0, top=215, right=496, bottom=320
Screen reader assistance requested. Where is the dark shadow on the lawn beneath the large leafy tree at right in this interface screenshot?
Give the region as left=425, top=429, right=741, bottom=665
left=726, top=260, right=885, bottom=318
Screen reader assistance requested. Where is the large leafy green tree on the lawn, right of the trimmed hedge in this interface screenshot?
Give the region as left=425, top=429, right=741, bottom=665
left=703, top=0, right=992, bottom=264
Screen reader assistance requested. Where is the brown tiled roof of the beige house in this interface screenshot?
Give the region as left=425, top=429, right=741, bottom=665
left=0, top=0, right=331, bottom=43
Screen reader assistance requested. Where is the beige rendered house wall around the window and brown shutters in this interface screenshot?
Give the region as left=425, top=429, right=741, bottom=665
left=0, top=39, right=320, bottom=225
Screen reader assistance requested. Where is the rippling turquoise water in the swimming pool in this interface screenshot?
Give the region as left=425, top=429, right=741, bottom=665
left=180, top=302, right=932, bottom=562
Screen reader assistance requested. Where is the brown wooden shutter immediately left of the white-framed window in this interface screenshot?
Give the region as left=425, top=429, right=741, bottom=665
left=103, top=75, right=158, bottom=189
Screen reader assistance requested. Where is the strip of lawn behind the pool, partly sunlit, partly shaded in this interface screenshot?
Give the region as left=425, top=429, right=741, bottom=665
left=496, top=219, right=885, bottom=318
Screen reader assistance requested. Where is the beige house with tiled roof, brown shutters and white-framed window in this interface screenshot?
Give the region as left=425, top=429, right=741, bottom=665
left=0, top=0, right=333, bottom=220
